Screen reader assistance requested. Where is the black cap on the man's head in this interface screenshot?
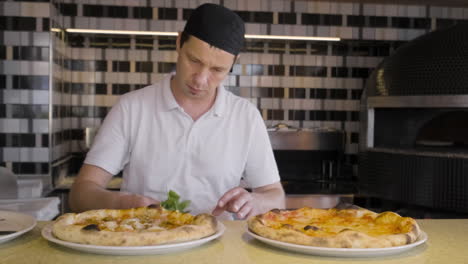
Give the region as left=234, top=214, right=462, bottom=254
left=184, top=4, right=245, bottom=55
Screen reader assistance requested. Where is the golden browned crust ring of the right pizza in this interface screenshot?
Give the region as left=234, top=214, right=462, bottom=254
left=248, top=208, right=421, bottom=248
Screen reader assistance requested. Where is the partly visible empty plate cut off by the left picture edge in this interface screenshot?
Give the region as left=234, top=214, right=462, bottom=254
left=0, top=210, right=36, bottom=243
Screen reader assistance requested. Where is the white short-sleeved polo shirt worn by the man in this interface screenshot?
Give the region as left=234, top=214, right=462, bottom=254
left=85, top=75, right=280, bottom=218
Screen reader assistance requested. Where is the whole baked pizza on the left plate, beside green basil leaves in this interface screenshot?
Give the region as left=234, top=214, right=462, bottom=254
left=52, top=205, right=217, bottom=246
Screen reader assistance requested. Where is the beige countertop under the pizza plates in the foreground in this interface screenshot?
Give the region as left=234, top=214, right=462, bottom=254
left=0, top=219, right=468, bottom=264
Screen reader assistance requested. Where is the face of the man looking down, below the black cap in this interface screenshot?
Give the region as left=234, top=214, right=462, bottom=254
left=174, top=36, right=235, bottom=99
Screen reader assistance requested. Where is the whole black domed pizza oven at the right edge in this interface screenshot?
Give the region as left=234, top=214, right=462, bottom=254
left=359, top=24, right=468, bottom=214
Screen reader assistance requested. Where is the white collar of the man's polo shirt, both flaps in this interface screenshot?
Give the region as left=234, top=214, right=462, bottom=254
left=162, top=73, right=226, bottom=116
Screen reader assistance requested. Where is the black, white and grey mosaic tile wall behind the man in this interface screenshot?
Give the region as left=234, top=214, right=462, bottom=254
left=0, top=0, right=468, bottom=190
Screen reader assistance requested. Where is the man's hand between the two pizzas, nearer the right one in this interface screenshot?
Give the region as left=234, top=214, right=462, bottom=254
left=212, top=187, right=254, bottom=219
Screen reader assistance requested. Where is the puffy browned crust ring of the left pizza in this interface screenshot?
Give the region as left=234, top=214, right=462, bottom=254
left=52, top=207, right=217, bottom=246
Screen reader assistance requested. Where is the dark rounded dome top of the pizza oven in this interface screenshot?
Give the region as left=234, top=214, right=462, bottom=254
left=366, top=23, right=468, bottom=96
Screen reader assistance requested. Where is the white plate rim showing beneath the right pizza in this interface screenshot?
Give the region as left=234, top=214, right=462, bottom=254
left=247, top=230, right=427, bottom=257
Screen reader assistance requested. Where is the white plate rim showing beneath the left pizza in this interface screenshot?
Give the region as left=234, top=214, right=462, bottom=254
left=42, top=222, right=226, bottom=255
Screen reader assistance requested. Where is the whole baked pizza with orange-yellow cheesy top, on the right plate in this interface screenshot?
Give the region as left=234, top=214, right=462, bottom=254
left=248, top=207, right=421, bottom=248
